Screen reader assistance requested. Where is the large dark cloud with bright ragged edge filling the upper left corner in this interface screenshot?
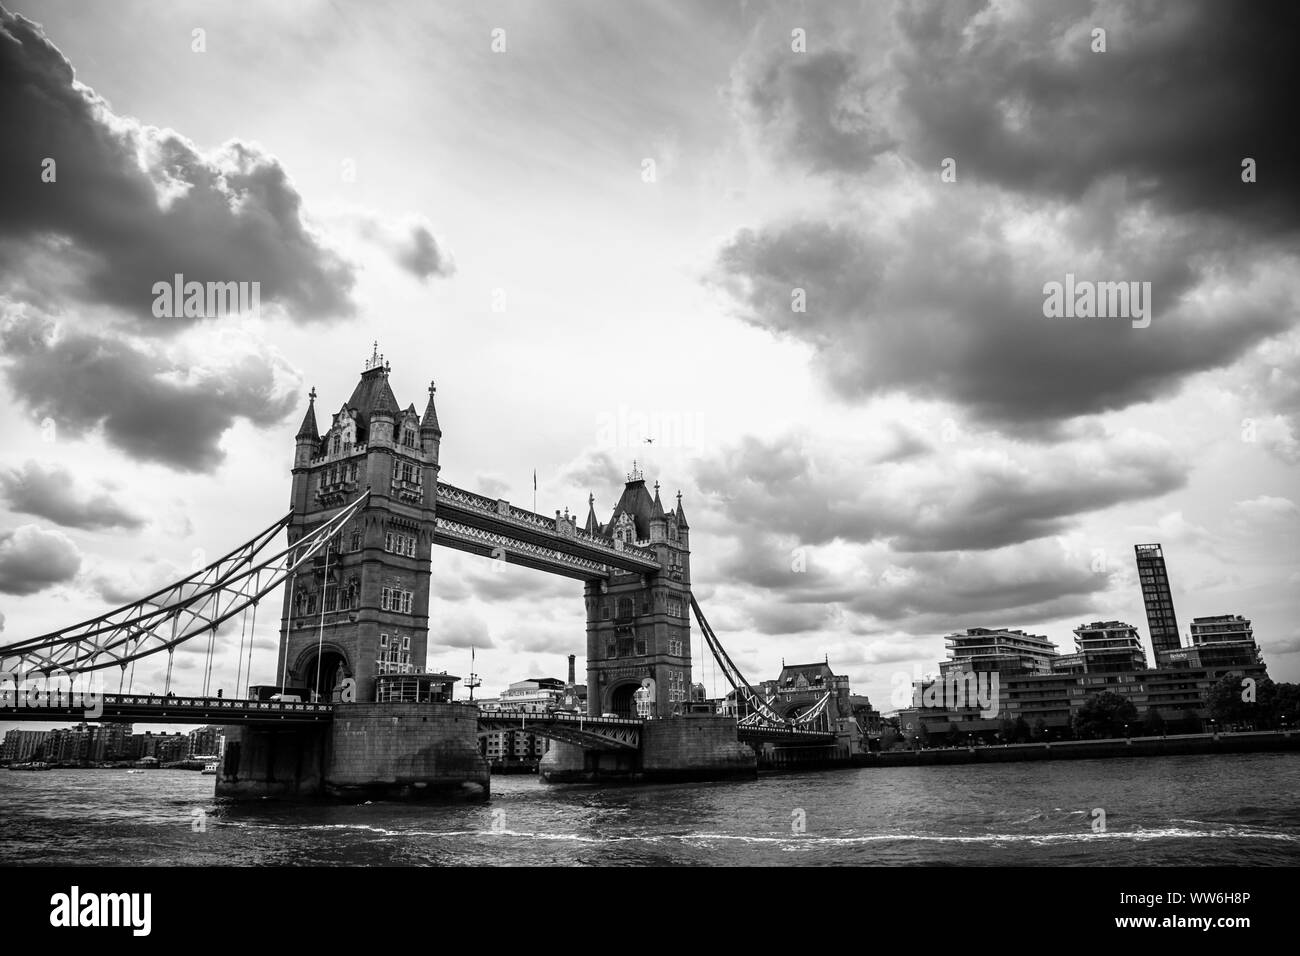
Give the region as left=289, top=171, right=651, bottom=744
left=0, top=8, right=356, bottom=319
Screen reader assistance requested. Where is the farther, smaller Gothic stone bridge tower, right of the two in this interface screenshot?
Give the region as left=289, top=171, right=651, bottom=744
left=585, top=463, right=690, bottom=717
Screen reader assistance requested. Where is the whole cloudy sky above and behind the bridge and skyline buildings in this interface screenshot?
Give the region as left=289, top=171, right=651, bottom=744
left=0, top=0, right=1300, bottom=728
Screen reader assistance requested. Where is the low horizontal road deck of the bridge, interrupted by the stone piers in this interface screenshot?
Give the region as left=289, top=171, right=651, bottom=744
left=0, top=689, right=835, bottom=750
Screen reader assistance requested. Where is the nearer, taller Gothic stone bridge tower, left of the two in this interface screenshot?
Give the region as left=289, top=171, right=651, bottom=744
left=276, top=343, right=442, bottom=702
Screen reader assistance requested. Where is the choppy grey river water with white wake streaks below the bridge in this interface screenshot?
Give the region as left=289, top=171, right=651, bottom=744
left=0, top=754, right=1300, bottom=866
